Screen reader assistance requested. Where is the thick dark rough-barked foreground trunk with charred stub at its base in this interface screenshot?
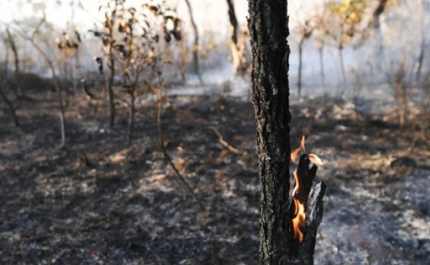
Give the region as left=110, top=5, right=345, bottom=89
left=248, top=0, right=325, bottom=265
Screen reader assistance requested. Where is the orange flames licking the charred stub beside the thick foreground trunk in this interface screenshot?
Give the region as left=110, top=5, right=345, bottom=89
left=291, top=136, right=323, bottom=243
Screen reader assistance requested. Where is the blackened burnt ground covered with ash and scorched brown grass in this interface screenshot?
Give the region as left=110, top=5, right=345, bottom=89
left=0, top=87, right=430, bottom=264
